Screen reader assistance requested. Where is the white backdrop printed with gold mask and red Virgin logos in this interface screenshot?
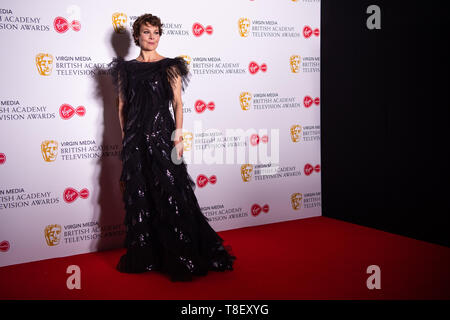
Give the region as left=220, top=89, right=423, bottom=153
left=0, top=0, right=321, bottom=266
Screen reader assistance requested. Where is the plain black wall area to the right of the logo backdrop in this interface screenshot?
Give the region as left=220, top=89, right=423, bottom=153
left=320, top=0, right=450, bottom=246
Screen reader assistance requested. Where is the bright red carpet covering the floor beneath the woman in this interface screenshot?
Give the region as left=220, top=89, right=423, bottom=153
left=0, top=217, right=450, bottom=300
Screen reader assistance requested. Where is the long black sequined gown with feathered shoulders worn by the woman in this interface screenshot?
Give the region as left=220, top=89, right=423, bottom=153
left=109, top=57, right=236, bottom=281
